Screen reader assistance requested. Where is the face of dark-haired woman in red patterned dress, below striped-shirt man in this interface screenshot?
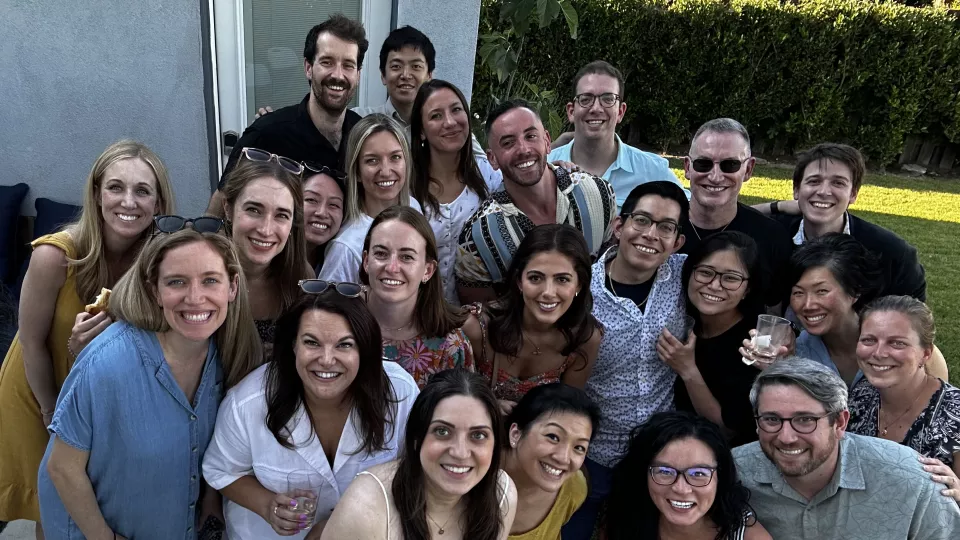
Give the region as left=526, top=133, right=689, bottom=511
left=518, top=251, right=580, bottom=325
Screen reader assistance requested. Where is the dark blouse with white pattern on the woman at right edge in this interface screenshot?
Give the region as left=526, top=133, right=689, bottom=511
left=847, top=378, right=960, bottom=466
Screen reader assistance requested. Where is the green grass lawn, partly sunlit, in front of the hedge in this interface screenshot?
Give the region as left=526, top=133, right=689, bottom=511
left=671, top=160, right=960, bottom=386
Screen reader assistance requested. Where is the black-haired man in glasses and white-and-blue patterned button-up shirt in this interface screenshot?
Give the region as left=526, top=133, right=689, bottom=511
left=563, top=181, right=689, bottom=538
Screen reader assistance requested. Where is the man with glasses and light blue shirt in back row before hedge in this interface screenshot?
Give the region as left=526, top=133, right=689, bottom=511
left=548, top=60, right=689, bottom=207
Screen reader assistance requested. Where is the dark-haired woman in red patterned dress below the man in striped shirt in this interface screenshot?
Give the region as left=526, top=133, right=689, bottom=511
left=463, top=224, right=603, bottom=414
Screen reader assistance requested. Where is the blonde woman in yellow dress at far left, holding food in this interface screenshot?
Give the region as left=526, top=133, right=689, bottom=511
left=0, top=141, right=174, bottom=538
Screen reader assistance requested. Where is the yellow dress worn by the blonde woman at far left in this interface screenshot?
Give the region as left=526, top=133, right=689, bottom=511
left=0, top=232, right=85, bottom=521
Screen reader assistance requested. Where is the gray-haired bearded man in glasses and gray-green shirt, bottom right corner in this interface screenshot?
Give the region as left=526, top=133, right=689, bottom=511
left=733, top=358, right=960, bottom=540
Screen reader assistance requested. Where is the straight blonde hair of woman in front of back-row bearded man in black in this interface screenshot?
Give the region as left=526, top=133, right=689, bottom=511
left=343, top=113, right=413, bottom=223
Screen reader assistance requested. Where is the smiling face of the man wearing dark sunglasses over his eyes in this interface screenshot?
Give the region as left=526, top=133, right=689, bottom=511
left=683, top=131, right=754, bottom=212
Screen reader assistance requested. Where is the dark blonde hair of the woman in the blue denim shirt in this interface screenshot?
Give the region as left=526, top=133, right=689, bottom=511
left=110, top=228, right=263, bottom=388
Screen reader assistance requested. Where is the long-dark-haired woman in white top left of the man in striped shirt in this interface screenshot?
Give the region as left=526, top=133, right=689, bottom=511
left=410, top=79, right=503, bottom=305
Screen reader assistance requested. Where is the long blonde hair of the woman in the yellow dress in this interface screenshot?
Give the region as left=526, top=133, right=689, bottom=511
left=64, top=139, right=174, bottom=302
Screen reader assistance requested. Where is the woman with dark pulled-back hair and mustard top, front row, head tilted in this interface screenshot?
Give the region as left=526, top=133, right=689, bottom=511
left=503, top=383, right=600, bottom=540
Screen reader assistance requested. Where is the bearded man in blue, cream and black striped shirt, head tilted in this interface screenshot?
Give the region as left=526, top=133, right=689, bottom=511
left=454, top=99, right=617, bottom=304
